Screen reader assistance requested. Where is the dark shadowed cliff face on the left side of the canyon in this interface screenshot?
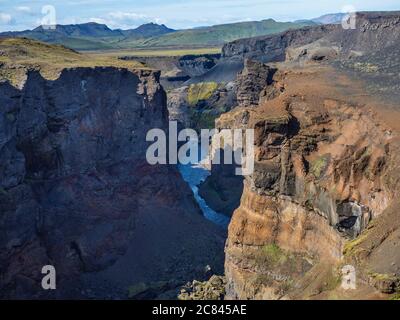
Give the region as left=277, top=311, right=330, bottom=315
left=0, top=67, right=223, bottom=298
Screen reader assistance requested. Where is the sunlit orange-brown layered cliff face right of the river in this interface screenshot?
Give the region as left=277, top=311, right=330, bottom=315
left=217, top=63, right=394, bottom=299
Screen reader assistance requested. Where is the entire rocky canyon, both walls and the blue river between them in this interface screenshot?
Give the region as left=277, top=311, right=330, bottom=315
left=0, top=12, right=400, bottom=300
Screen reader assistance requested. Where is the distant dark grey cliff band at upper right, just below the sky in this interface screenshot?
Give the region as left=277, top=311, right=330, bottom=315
left=222, top=12, right=400, bottom=62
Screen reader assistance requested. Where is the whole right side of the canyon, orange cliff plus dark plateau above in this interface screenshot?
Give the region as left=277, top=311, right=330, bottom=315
left=167, top=13, right=400, bottom=300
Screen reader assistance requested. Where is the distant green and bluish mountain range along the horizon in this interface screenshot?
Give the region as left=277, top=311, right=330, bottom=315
left=0, top=13, right=344, bottom=50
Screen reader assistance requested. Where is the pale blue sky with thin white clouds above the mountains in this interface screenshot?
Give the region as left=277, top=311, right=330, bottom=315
left=0, top=0, right=400, bottom=31
